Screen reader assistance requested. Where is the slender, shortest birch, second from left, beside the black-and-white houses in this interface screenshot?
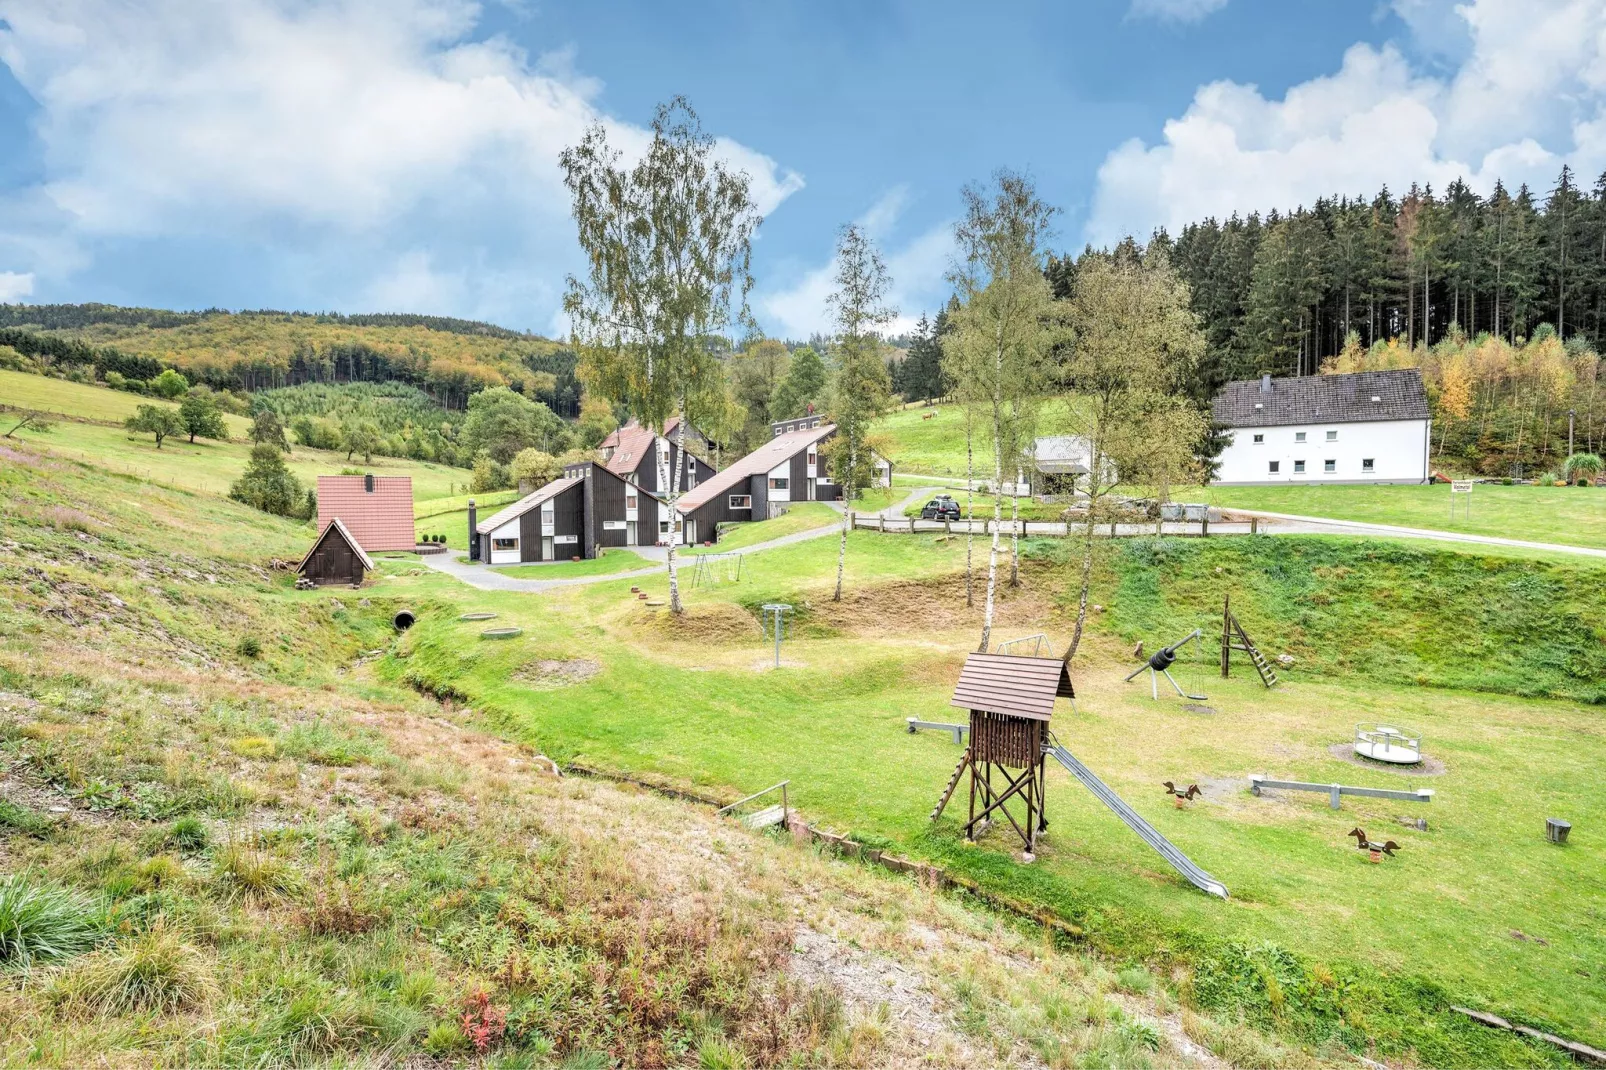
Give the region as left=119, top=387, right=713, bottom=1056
left=829, top=223, right=898, bottom=601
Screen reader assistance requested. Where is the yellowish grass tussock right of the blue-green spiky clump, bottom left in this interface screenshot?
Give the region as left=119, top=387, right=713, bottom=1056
left=53, top=924, right=215, bottom=1014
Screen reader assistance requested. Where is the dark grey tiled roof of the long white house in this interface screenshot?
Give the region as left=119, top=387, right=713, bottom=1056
left=1211, top=368, right=1428, bottom=427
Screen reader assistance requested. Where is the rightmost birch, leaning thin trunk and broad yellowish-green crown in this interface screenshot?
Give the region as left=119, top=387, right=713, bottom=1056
left=1063, top=246, right=1209, bottom=664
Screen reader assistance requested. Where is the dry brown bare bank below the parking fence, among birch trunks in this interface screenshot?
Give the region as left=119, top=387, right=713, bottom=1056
left=809, top=561, right=1054, bottom=639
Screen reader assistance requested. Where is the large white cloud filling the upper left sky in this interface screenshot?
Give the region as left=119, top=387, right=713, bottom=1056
left=0, top=0, right=803, bottom=323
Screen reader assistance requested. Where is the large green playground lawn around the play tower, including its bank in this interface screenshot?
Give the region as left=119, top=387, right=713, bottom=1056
left=375, top=532, right=1606, bottom=1062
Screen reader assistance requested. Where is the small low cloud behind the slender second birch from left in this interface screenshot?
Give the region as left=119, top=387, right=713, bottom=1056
left=753, top=185, right=954, bottom=339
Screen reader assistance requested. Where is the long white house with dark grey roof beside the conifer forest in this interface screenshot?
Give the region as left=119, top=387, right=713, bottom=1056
left=1211, top=368, right=1433, bottom=484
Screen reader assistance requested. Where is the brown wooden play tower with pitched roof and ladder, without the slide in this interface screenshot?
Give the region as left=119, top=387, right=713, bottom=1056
left=931, top=654, right=1076, bottom=855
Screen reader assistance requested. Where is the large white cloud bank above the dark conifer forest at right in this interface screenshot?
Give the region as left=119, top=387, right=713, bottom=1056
left=1086, top=0, right=1606, bottom=244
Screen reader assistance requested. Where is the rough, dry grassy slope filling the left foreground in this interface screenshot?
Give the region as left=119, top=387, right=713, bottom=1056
left=0, top=445, right=1310, bottom=1067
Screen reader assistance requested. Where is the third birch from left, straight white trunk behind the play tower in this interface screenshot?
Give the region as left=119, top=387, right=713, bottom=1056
left=943, top=170, right=1063, bottom=652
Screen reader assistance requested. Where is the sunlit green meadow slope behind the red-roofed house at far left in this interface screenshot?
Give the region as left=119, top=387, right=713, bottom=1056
left=0, top=371, right=469, bottom=501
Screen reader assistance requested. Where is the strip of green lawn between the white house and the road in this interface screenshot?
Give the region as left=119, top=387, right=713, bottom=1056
left=1207, top=484, right=1606, bottom=548
